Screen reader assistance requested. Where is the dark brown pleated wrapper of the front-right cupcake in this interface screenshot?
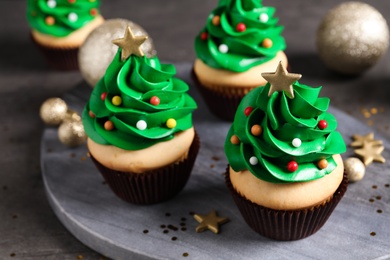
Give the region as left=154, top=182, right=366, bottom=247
left=225, top=168, right=348, bottom=241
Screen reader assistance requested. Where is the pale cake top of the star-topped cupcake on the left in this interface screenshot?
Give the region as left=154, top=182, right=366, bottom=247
left=87, top=127, right=195, bottom=173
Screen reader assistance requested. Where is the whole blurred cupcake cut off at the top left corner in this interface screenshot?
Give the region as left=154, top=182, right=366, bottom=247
left=27, top=0, right=104, bottom=70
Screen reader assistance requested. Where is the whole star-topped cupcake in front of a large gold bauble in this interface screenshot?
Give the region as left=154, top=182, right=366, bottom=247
left=82, top=27, right=199, bottom=204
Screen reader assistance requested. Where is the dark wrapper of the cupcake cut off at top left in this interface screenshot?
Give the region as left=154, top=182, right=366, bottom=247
left=31, top=33, right=79, bottom=70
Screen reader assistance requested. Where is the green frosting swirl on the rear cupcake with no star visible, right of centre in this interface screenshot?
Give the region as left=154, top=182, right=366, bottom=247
left=195, top=0, right=286, bottom=72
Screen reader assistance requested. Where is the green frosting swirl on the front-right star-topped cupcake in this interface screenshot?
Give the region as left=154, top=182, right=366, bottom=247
left=225, top=82, right=346, bottom=183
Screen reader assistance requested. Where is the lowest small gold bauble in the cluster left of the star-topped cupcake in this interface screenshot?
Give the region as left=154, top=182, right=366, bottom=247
left=58, top=120, right=87, bottom=147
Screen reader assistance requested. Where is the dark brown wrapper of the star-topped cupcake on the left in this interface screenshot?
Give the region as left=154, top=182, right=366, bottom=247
left=91, top=134, right=200, bottom=205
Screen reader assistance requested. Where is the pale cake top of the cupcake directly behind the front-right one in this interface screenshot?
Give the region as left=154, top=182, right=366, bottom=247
left=194, top=51, right=288, bottom=89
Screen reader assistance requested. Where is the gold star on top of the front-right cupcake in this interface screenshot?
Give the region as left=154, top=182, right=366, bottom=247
left=261, top=62, right=302, bottom=98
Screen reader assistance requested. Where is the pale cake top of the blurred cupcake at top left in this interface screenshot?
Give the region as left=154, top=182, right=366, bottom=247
left=31, top=15, right=104, bottom=48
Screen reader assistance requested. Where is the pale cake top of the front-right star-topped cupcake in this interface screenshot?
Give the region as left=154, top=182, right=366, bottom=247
left=229, top=154, right=344, bottom=210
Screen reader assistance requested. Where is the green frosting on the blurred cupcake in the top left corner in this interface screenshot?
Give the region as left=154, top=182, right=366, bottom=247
left=27, top=0, right=100, bottom=37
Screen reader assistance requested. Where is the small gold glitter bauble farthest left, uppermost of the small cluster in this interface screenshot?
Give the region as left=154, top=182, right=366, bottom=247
left=39, top=98, right=68, bottom=126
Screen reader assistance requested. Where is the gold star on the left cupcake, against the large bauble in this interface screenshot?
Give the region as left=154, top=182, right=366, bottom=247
left=112, top=26, right=148, bottom=61
